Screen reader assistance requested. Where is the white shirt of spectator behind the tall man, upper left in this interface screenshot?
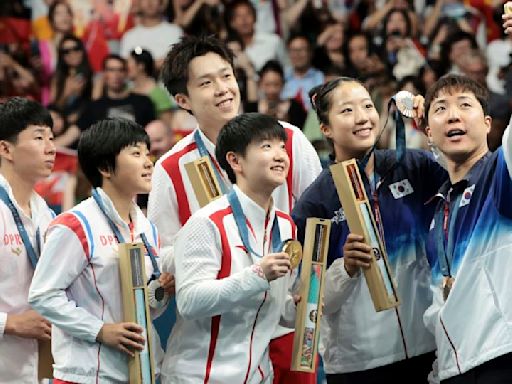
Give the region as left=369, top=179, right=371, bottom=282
left=120, top=21, right=183, bottom=60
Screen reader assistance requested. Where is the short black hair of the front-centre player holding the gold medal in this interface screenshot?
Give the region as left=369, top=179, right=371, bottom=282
left=215, top=113, right=287, bottom=184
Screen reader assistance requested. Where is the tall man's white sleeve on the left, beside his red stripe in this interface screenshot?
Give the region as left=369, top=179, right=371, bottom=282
left=148, top=163, right=181, bottom=274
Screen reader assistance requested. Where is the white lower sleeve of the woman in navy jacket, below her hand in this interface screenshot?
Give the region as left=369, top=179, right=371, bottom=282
left=323, top=257, right=364, bottom=315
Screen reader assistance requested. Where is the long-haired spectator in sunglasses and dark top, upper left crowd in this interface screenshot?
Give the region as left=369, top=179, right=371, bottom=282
left=51, top=35, right=92, bottom=124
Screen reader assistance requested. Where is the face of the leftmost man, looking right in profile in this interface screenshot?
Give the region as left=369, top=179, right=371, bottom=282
left=0, top=125, right=55, bottom=183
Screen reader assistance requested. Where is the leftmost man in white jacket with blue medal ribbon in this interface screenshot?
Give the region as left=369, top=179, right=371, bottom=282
left=0, top=97, right=55, bottom=384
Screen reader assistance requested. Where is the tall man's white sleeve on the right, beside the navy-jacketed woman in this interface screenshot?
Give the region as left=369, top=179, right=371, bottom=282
left=292, top=128, right=322, bottom=201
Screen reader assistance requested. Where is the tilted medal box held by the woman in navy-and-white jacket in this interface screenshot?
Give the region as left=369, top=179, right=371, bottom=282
left=330, top=159, right=400, bottom=312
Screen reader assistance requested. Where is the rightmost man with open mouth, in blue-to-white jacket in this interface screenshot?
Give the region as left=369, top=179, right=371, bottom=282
left=424, top=75, right=512, bottom=384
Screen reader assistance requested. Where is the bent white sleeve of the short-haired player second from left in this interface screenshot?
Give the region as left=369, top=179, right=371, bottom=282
left=28, top=225, right=103, bottom=343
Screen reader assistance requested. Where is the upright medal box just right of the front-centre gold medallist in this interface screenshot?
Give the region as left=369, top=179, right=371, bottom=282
left=291, top=217, right=331, bottom=372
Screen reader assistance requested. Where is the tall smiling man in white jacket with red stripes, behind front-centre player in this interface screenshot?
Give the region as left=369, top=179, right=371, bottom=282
left=148, top=36, right=321, bottom=384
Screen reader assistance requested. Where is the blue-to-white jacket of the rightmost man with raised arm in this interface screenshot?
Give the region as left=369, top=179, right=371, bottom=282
left=424, top=124, right=512, bottom=380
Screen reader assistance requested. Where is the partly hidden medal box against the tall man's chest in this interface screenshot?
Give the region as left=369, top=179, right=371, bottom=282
left=185, top=156, right=222, bottom=208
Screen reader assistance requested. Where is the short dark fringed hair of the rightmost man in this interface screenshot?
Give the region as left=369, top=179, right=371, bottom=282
left=425, top=73, right=489, bottom=125
